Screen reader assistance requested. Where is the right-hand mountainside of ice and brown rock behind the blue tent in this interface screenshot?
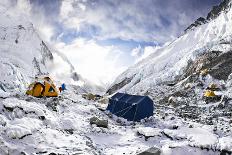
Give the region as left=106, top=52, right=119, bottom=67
left=107, top=0, right=232, bottom=112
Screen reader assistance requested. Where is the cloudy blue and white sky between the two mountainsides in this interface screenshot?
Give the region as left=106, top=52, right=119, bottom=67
left=8, top=0, right=221, bottom=87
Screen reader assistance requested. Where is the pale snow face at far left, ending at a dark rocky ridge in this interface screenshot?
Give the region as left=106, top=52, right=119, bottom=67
left=0, top=3, right=49, bottom=91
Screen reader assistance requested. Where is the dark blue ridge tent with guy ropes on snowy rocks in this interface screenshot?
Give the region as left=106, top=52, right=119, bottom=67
left=106, top=93, right=154, bottom=121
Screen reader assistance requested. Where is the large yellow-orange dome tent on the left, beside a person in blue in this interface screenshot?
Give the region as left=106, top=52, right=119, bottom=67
left=26, top=77, right=58, bottom=97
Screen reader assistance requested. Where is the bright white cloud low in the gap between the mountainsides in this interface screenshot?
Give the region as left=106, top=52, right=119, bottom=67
left=56, top=38, right=126, bottom=86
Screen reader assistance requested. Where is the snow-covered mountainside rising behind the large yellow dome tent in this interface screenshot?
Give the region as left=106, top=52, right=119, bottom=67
left=0, top=1, right=99, bottom=92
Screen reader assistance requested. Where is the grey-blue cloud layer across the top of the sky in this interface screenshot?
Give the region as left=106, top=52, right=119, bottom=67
left=9, top=0, right=220, bottom=43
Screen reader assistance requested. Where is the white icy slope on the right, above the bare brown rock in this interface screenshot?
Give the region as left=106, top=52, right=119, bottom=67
left=108, top=1, right=232, bottom=94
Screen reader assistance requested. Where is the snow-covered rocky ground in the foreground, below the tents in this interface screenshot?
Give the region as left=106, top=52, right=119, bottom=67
left=0, top=91, right=232, bottom=155
